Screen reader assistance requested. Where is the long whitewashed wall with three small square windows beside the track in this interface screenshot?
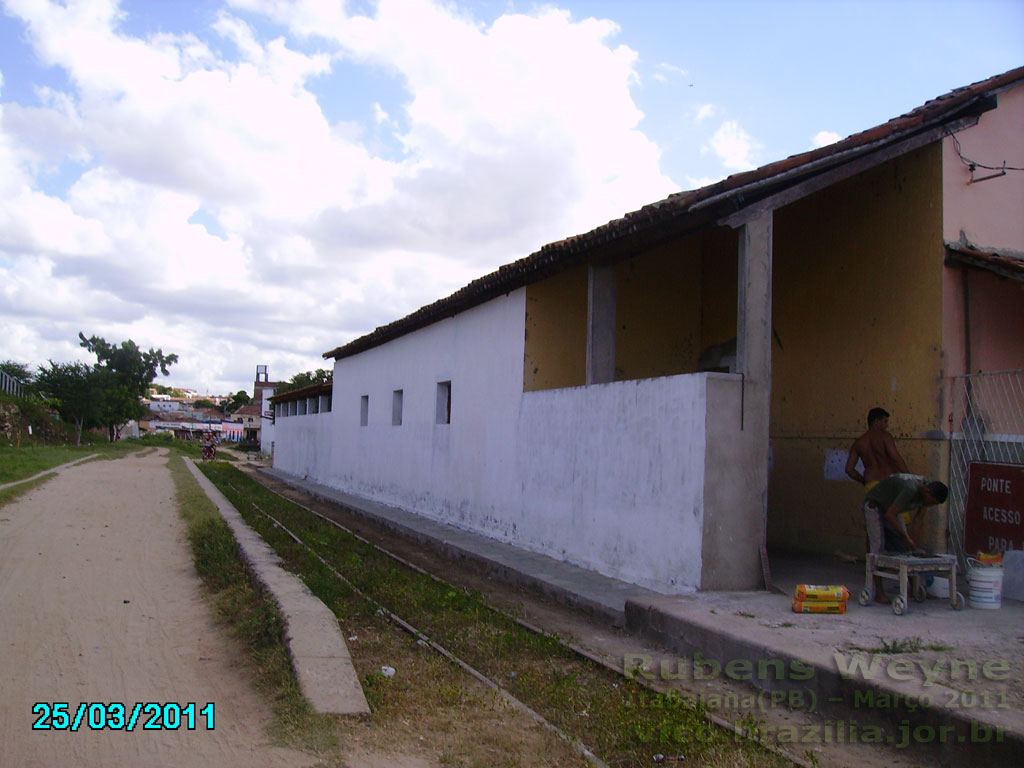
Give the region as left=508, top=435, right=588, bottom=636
left=274, top=290, right=707, bottom=592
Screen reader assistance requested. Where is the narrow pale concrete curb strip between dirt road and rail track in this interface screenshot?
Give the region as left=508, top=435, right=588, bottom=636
left=185, top=459, right=370, bottom=715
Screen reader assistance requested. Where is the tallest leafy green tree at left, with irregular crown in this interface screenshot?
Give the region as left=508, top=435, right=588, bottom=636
left=78, top=332, right=178, bottom=442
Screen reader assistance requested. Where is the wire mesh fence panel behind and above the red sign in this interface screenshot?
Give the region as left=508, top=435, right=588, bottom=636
left=948, top=369, right=1024, bottom=566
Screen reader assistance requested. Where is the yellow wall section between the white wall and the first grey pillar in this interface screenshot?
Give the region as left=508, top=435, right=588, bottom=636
left=522, top=266, right=587, bottom=391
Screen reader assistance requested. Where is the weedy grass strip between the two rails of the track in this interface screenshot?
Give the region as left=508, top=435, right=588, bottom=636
left=203, top=464, right=791, bottom=766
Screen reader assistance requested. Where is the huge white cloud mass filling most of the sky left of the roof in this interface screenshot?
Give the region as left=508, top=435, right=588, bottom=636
left=0, top=0, right=678, bottom=391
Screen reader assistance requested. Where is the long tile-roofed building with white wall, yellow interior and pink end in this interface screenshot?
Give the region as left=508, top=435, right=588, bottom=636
left=272, top=69, right=1024, bottom=593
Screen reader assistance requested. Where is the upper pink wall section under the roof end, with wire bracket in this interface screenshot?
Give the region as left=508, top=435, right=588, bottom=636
left=942, top=84, right=1024, bottom=249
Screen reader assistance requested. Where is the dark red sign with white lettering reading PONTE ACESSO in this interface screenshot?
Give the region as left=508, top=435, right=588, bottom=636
left=964, top=462, right=1024, bottom=555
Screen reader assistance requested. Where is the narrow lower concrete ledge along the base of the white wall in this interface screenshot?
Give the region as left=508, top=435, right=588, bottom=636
left=259, top=468, right=658, bottom=627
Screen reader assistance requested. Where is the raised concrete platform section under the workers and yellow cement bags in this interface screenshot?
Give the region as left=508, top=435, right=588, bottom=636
left=627, top=566, right=1024, bottom=768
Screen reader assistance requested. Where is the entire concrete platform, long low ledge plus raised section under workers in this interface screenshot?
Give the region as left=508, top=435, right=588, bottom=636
left=260, top=468, right=1024, bottom=768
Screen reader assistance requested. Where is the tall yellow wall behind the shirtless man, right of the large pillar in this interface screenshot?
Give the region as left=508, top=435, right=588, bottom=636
left=768, top=144, right=945, bottom=555
